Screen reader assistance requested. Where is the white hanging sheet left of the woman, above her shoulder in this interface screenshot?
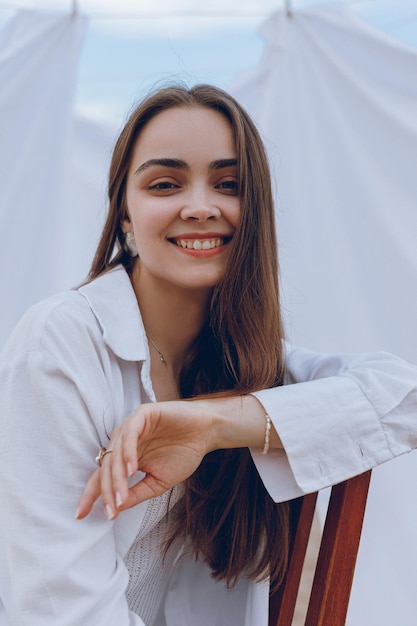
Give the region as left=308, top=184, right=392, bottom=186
left=0, top=11, right=84, bottom=346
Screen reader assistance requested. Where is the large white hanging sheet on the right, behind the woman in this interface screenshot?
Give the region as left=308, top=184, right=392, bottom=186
left=233, top=8, right=417, bottom=626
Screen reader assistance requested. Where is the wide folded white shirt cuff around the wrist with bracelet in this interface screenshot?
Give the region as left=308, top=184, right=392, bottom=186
left=251, top=377, right=393, bottom=502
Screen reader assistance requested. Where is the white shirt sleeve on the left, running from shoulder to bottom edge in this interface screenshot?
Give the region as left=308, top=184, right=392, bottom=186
left=0, top=296, right=144, bottom=626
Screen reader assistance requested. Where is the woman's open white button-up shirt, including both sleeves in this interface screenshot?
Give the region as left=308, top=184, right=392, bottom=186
left=0, top=267, right=417, bottom=626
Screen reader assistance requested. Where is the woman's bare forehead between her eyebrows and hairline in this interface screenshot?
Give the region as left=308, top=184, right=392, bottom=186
left=133, top=106, right=236, bottom=163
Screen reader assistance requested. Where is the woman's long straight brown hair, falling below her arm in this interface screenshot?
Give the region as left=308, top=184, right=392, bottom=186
left=89, top=85, right=289, bottom=586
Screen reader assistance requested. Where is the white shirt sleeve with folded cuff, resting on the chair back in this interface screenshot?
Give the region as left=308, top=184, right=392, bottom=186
left=252, top=344, right=417, bottom=502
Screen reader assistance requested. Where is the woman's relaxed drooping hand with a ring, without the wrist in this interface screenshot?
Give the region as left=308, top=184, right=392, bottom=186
left=77, top=401, right=215, bottom=519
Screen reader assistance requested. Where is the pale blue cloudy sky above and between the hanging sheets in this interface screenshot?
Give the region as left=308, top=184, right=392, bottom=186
left=0, top=0, right=417, bottom=124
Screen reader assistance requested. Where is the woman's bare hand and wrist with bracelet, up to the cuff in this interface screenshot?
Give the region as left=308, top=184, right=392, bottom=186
left=78, top=395, right=281, bottom=519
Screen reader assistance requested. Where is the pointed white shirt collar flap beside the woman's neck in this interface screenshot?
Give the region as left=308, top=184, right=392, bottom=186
left=78, top=265, right=148, bottom=361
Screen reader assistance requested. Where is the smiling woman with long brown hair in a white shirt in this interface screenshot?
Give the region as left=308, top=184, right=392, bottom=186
left=0, top=86, right=417, bottom=626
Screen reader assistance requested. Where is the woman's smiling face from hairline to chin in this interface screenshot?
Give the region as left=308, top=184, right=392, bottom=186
left=122, top=106, right=240, bottom=289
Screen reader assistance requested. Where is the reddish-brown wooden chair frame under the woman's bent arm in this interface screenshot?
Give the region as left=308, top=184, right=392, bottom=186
left=269, top=470, right=371, bottom=626
